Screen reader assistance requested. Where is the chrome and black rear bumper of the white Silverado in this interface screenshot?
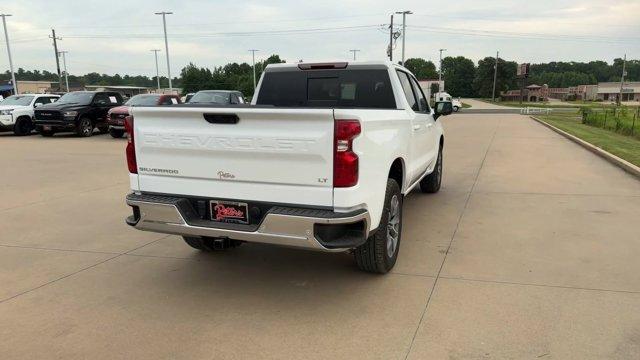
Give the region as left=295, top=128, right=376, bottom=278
left=126, top=194, right=371, bottom=251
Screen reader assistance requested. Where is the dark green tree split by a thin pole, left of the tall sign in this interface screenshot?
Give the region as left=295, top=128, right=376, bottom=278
left=473, top=57, right=518, bottom=98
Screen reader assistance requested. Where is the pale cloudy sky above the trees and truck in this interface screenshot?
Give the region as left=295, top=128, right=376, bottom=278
left=0, top=0, right=640, bottom=76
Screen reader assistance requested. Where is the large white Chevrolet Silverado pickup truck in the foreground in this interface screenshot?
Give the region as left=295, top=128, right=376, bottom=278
left=125, top=62, right=452, bottom=273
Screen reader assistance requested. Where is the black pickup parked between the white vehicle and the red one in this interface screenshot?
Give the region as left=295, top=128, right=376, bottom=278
left=34, top=91, right=122, bottom=137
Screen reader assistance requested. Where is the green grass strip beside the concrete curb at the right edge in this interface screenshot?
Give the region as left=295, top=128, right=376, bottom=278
left=536, top=112, right=640, bottom=166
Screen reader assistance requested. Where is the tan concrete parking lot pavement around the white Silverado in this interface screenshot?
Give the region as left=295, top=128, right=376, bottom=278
left=0, top=114, right=640, bottom=359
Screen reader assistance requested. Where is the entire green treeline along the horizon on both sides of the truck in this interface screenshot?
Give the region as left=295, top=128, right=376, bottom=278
left=0, top=55, right=640, bottom=97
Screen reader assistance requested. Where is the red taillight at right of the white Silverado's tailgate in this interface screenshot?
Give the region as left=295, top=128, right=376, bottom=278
left=333, top=120, right=361, bottom=187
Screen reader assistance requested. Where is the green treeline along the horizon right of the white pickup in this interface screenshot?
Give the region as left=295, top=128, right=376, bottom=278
left=406, top=56, right=640, bottom=97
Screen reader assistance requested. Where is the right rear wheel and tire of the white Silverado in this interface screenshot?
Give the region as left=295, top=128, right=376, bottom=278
left=353, top=179, right=403, bottom=274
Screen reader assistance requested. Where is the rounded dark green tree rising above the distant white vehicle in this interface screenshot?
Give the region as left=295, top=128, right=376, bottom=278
left=442, top=56, right=476, bottom=97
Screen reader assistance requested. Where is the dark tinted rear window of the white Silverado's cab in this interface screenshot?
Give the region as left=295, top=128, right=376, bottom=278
left=256, top=69, right=396, bottom=109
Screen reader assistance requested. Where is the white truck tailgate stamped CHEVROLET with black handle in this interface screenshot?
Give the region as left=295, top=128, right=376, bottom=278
left=131, top=107, right=334, bottom=206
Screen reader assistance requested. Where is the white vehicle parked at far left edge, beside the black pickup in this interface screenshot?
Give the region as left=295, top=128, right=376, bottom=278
left=0, top=94, right=60, bottom=135
